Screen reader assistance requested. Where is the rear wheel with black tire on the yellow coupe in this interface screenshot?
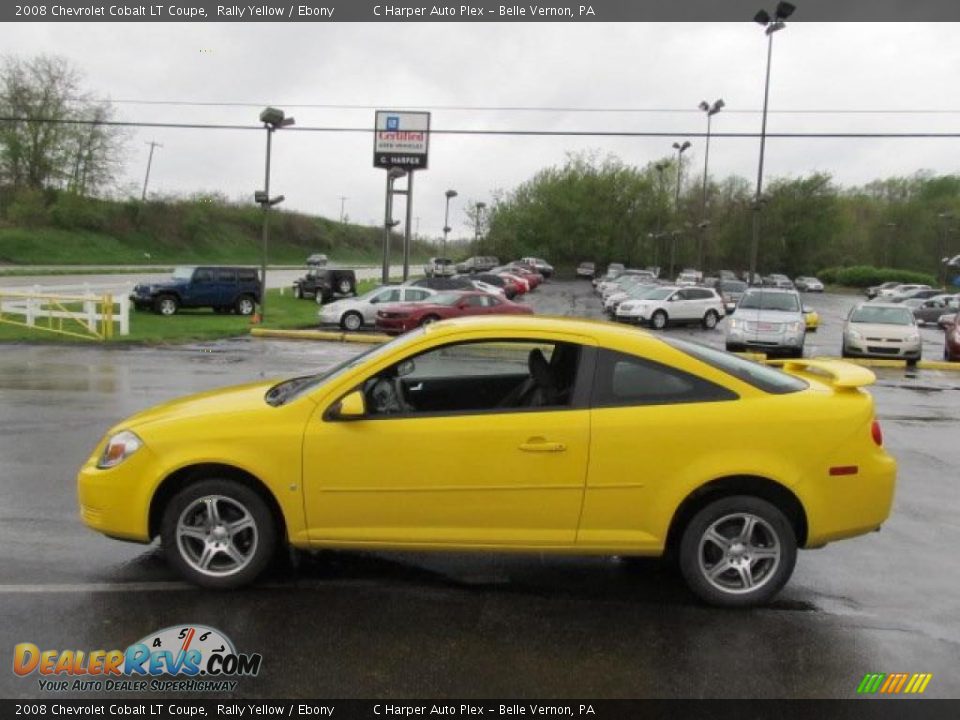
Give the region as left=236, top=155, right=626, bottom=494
left=679, top=495, right=797, bottom=607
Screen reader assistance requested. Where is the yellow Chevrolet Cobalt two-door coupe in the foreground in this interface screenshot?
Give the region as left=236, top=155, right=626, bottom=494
left=78, top=316, right=896, bottom=606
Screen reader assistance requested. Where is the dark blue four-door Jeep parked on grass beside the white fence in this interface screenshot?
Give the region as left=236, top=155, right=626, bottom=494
left=130, top=266, right=260, bottom=315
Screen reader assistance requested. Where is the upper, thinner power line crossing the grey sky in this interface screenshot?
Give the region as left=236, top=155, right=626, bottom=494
left=56, top=97, right=960, bottom=115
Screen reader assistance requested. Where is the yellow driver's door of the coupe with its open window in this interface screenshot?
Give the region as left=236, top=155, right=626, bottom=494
left=303, top=341, right=590, bottom=548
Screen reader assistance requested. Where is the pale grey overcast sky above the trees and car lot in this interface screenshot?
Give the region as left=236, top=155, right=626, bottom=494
left=0, top=22, right=960, bottom=236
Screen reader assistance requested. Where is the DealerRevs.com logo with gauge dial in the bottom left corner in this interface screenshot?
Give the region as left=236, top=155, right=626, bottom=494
left=13, top=625, right=263, bottom=692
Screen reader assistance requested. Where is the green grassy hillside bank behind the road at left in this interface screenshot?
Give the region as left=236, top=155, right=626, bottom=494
left=0, top=191, right=431, bottom=265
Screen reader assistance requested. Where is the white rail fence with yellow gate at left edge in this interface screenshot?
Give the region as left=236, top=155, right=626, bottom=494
left=0, top=288, right=130, bottom=340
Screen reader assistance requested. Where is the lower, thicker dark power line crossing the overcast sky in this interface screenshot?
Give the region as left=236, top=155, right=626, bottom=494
left=0, top=116, right=960, bottom=140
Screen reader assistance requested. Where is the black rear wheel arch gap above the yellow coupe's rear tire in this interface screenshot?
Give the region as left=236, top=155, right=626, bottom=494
left=665, top=475, right=808, bottom=553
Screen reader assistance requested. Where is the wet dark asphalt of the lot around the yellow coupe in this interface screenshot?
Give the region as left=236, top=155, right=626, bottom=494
left=0, top=282, right=960, bottom=699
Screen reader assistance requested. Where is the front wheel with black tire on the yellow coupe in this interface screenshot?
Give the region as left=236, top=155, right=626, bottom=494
left=160, top=478, right=277, bottom=590
